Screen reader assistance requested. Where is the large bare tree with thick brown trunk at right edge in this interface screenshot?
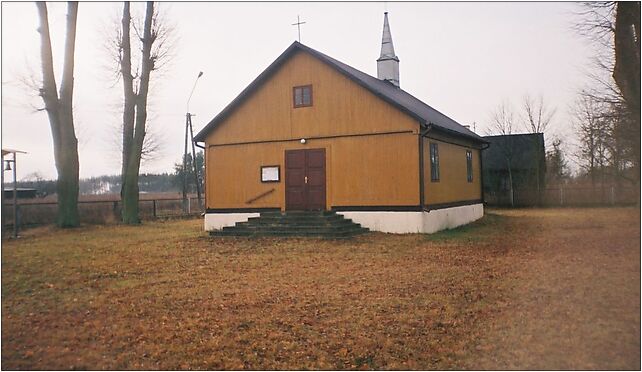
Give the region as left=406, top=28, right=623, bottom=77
left=576, top=2, right=640, bottom=198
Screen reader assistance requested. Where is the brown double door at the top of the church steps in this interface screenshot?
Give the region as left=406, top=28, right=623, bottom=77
left=285, top=149, right=325, bottom=210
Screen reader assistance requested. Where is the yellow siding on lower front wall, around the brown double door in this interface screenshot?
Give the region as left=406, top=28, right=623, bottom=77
left=206, top=133, right=419, bottom=209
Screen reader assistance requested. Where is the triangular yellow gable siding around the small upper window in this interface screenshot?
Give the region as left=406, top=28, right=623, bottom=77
left=205, top=51, right=419, bottom=145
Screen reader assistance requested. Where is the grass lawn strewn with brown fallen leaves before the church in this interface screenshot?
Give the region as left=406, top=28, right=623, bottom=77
left=2, top=208, right=640, bottom=369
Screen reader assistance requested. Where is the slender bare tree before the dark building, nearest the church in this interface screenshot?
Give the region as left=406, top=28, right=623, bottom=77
left=489, top=102, right=515, bottom=207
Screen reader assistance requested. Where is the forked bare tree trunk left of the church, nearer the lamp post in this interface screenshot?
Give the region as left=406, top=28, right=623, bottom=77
left=121, top=1, right=155, bottom=224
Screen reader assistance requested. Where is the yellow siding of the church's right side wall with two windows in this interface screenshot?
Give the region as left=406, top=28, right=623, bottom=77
left=423, top=138, right=481, bottom=205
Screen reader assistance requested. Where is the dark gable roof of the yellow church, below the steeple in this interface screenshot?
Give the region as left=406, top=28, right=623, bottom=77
left=194, top=41, right=486, bottom=143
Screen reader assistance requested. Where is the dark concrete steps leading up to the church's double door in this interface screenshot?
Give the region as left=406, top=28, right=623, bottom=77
left=210, top=211, right=369, bottom=239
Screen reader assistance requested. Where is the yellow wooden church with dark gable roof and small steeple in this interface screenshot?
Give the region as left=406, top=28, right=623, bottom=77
left=195, top=13, right=487, bottom=233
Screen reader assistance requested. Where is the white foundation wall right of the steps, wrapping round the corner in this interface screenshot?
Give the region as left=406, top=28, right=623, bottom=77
left=337, top=203, right=484, bottom=234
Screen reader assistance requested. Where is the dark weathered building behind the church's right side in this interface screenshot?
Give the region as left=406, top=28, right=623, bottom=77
left=482, top=133, right=546, bottom=206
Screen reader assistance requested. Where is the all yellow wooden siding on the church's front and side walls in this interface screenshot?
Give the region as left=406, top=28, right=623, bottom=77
left=200, top=46, right=481, bottom=209
